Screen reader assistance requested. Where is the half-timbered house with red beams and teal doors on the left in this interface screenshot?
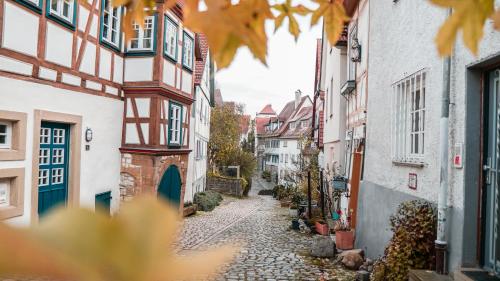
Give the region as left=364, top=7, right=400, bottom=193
left=0, top=0, right=199, bottom=225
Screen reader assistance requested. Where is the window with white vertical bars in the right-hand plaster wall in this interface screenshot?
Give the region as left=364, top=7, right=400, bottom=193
left=392, top=71, right=426, bottom=162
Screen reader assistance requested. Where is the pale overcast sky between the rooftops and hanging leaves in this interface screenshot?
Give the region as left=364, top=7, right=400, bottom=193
left=216, top=11, right=321, bottom=116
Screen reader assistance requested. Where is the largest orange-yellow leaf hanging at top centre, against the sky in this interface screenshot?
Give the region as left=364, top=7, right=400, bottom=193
left=184, top=0, right=273, bottom=69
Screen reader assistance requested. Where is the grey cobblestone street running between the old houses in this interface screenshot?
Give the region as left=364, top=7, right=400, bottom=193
left=178, top=178, right=355, bottom=280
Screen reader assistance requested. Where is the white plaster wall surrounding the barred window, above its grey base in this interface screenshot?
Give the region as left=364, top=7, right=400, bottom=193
left=364, top=1, right=444, bottom=202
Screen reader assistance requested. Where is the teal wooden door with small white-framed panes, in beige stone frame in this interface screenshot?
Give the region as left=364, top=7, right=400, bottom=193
left=38, top=122, right=70, bottom=215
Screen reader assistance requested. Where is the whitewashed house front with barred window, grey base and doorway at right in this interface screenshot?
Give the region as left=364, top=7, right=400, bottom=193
left=348, top=1, right=500, bottom=275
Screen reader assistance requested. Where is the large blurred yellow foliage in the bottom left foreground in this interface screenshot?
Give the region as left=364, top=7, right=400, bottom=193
left=0, top=196, right=237, bottom=281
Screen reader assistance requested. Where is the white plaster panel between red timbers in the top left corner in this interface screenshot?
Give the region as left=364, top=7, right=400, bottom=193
left=2, top=1, right=38, bottom=56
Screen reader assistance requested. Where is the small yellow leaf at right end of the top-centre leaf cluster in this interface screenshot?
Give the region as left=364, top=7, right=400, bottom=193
left=311, top=0, right=349, bottom=45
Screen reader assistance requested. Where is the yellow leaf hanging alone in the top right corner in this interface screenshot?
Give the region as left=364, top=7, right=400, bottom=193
left=430, top=0, right=494, bottom=56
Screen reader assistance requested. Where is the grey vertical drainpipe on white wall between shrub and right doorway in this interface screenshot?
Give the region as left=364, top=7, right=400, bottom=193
left=435, top=9, right=452, bottom=274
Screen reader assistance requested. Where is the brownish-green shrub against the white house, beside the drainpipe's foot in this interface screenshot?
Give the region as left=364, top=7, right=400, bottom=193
left=370, top=200, right=437, bottom=281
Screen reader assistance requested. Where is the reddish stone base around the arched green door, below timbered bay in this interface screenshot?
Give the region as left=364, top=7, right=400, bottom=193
left=120, top=153, right=188, bottom=210
